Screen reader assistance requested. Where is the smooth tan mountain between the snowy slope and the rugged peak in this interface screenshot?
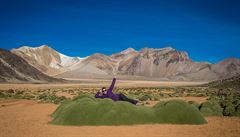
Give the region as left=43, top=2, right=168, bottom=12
left=58, top=48, right=137, bottom=78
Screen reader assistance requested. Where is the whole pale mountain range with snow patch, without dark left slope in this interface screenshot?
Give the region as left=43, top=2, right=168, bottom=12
left=7, top=45, right=240, bottom=81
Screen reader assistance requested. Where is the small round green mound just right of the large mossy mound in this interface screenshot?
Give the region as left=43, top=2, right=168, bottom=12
left=199, top=101, right=223, bottom=116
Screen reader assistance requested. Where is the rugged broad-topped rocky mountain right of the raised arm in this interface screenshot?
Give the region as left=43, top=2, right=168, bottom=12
left=123, top=47, right=191, bottom=77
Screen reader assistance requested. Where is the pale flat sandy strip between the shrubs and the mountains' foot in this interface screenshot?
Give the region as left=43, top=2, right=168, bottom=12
left=0, top=80, right=205, bottom=90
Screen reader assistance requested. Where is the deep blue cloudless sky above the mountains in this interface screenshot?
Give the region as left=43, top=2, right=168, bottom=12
left=0, top=0, right=240, bottom=63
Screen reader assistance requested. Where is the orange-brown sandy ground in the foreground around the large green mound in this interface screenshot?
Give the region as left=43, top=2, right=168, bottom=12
left=0, top=100, right=240, bottom=137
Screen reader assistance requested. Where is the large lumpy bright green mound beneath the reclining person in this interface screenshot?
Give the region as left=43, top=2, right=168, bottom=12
left=51, top=95, right=206, bottom=125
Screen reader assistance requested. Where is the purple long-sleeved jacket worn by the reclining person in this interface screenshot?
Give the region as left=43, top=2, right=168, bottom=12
left=95, top=78, right=119, bottom=101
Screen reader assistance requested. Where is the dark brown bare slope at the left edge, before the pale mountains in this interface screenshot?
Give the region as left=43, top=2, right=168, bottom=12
left=0, top=49, right=63, bottom=83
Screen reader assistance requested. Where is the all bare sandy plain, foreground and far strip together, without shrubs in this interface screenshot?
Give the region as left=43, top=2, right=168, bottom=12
left=0, top=80, right=240, bottom=137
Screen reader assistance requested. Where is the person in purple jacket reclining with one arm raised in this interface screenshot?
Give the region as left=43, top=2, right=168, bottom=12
left=95, top=78, right=138, bottom=105
